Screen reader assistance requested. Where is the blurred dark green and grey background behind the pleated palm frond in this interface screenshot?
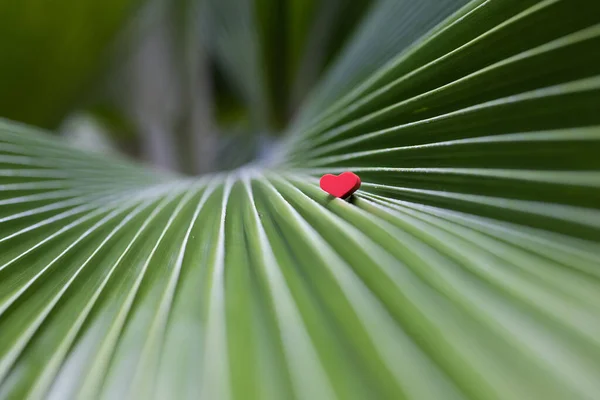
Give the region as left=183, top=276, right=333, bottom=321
left=0, top=0, right=384, bottom=174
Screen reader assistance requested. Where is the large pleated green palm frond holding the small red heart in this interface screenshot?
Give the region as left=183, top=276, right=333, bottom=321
left=0, top=0, right=600, bottom=400
